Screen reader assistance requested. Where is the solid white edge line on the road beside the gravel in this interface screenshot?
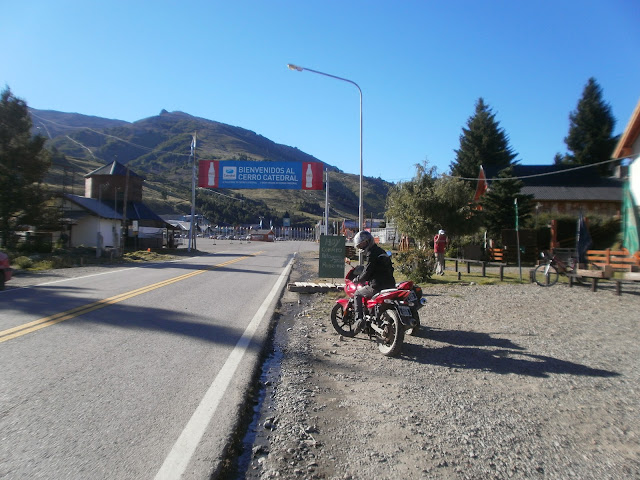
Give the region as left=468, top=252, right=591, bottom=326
left=155, top=259, right=293, bottom=480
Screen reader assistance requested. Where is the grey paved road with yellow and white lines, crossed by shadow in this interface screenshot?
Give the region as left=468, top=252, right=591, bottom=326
left=0, top=239, right=317, bottom=479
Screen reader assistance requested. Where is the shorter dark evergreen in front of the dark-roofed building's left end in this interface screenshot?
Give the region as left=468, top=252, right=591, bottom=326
left=480, top=167, right=533, bottom=239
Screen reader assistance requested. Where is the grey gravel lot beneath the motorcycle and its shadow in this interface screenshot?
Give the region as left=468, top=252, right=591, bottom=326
left=243, top=253, right=640, bottom=480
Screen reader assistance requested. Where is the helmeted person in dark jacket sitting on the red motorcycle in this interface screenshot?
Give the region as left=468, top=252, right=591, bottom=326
left=353, top=230, right=396, bottom=330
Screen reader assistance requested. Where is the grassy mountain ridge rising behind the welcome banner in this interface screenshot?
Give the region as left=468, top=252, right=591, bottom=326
left=30, top=109, right=391, bottom=222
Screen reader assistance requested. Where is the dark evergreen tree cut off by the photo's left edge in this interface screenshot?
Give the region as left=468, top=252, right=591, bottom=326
left=0, top=87, right=50, bottom=246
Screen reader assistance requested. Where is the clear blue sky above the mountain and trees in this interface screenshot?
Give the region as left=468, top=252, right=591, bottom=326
left=0, top=0, right=640, bottom=182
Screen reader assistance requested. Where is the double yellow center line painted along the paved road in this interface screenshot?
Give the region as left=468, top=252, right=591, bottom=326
left=0, top=251, right=262, bottom=343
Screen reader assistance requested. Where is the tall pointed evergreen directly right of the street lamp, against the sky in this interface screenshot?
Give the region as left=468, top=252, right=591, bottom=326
left=451, top=98, right=517, bottom=184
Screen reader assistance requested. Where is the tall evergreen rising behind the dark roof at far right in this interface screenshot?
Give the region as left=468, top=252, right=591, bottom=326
left=555, top=77, right=617, bottom=175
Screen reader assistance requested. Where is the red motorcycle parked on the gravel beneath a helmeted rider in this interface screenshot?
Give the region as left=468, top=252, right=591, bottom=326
left=331, top=265, right=417, bottom=357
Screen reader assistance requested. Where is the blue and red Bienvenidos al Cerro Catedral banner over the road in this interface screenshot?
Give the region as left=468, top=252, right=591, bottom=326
left=198, top=160, right=324, bottom=190
